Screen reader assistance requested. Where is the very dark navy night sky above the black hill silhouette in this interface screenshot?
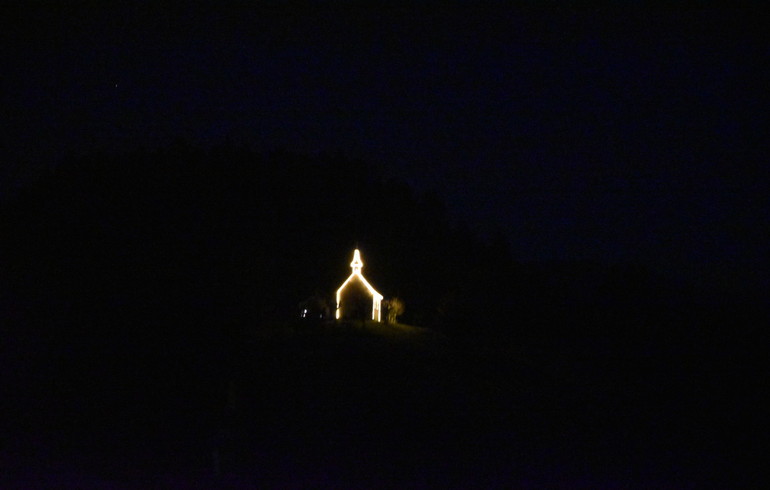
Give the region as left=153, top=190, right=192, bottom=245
left=0, top=6, right=770, bottom=276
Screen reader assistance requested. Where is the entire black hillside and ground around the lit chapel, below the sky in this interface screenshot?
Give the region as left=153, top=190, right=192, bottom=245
left=0, top=146, right=763, bottom=487
